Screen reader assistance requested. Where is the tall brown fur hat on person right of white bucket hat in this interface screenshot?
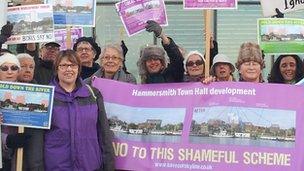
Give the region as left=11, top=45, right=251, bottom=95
left=235, top=42, right=265, bottom=69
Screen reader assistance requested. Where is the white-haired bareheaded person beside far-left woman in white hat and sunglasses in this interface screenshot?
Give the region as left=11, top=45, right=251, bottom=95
left=17, top=53, right=35, bottom=83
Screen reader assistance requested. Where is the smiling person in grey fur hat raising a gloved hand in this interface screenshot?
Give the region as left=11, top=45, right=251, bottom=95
left=137, top=20, right=184, bottom=84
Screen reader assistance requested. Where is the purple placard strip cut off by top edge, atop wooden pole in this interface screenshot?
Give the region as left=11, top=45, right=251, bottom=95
left=183, top=0, right=237, bottom=9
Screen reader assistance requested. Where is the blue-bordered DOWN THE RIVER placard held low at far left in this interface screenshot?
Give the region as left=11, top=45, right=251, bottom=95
left=0, top=81, right=54, bottom=129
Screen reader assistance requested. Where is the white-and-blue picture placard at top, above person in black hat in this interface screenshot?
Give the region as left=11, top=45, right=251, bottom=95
left=45, top=0, right=96, bottom=27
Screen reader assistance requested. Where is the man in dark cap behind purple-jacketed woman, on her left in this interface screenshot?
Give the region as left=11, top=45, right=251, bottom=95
left=33, top=42, right=60, bottom=85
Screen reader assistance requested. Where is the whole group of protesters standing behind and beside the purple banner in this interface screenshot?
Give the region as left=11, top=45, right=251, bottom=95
left=0, top=18, right=304, bottom=171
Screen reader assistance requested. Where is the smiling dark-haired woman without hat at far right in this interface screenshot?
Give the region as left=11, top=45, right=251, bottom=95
left=268, top=54, right=304, bottom=84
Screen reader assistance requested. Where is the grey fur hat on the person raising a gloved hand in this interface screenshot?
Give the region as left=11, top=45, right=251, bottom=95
left=140, top=46, right=166, bottom=61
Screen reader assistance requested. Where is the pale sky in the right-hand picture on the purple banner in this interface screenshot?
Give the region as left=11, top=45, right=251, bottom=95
left=193, top=106, right=296, bottom=129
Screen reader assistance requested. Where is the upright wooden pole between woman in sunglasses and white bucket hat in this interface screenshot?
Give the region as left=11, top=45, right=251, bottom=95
left=204, top=10, right=212, bottom=78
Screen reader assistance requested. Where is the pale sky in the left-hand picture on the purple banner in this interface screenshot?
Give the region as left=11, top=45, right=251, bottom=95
left=105, top=102, right=186, bottom=126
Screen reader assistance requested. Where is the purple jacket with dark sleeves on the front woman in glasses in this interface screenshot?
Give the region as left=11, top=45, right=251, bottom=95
left=44, top=79, right=114, bottom=171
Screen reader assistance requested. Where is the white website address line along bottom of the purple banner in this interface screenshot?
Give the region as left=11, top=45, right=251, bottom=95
left=154, top=163, right=213, bottom=170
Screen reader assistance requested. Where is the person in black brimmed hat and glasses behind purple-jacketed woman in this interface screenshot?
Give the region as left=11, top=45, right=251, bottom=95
left=73, top=37, right=101, bottom=79
